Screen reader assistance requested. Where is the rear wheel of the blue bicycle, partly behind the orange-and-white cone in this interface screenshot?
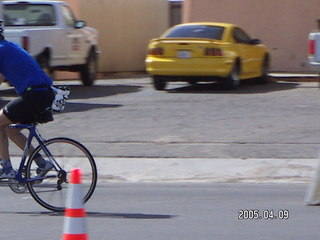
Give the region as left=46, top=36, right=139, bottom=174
left=26, top=138, right=98, bottom=212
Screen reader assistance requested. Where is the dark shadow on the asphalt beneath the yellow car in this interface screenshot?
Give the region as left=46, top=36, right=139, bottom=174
left=167, top=80, right=300, bottom=94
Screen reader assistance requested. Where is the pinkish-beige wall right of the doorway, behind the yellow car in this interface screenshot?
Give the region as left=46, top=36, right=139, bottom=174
left=183, top=0, right=320, bottom=72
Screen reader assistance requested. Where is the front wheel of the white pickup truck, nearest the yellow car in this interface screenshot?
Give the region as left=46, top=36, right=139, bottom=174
left=80, top=51, right=98, bottom=86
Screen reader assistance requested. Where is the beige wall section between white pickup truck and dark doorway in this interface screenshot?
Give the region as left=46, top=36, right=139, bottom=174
left=67, top=0, right=169, bottom=72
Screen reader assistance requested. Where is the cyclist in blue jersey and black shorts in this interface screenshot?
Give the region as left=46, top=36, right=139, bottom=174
left=0, top=21, right=54, bottom=179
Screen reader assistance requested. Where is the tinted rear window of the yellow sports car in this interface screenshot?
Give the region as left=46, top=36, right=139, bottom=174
left=165, top=25, right=224, bottom=40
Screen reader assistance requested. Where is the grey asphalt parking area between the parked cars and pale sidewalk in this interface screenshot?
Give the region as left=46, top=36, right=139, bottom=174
left=0, top=76, right=320, bottom=158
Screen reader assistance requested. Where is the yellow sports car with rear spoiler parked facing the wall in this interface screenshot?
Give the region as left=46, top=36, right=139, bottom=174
left=145, top=22, right=270, bottom=90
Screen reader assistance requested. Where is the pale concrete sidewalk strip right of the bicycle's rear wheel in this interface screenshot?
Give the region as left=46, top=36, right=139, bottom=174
left=96, top=158, right=318, bottom=183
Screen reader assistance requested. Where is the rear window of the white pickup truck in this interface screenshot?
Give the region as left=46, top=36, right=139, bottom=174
left=4, top=4, right=56, bottom=26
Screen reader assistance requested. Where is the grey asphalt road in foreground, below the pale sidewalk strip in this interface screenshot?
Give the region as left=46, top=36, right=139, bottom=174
left=0, top=183, right=320, bottom=240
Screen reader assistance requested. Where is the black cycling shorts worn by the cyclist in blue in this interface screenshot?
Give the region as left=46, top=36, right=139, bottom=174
left=3, top=89, right=55, bottom=123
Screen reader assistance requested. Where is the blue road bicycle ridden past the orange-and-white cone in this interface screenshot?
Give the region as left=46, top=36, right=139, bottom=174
left=0, top=89, right=98, bottom=212
